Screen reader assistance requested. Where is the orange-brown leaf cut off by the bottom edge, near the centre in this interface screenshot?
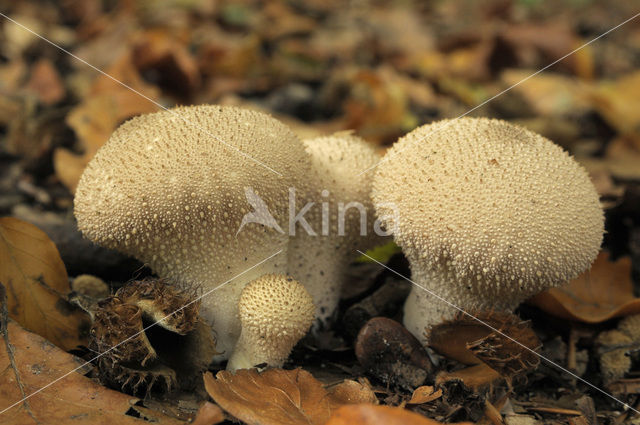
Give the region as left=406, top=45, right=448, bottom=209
left=325, top=404, right=472, bottom=425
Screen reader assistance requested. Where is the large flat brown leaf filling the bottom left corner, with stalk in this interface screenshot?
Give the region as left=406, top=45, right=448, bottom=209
left=0, top=286, right=183, bottom=425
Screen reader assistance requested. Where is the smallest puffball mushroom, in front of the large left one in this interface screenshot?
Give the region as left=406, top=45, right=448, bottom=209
left=227, top=274, right=315, bottom=371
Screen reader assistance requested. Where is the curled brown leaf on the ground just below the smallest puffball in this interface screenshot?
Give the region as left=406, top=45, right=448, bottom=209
left=204, top=369, right=375, bottom=425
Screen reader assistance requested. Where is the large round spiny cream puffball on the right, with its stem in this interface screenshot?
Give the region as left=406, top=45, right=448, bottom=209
left=372, top=118, right=604, bottom=337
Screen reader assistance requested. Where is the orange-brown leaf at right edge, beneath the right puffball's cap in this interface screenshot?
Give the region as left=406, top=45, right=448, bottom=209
left=528, top=252, right=640, bottom=323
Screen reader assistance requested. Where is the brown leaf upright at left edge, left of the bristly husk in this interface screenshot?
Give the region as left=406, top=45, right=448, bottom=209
left=0, top=217, right=90, bottom=350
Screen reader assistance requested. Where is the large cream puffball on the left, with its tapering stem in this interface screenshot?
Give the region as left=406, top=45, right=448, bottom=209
left=75, top=105, right=309, bottom=360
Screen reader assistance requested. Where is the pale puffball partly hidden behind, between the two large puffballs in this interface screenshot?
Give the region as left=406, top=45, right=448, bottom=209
left=288, top=131, right=384, bottom=325
